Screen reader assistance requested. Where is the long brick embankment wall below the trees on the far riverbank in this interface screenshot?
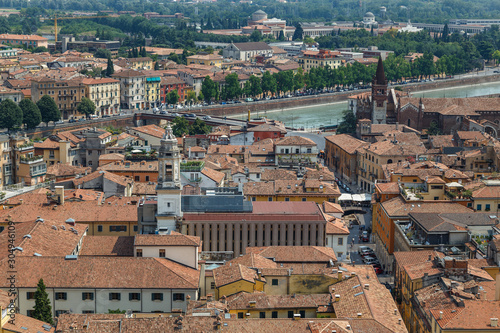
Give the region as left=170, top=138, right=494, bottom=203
left=193, top=74, right=500, bottom=117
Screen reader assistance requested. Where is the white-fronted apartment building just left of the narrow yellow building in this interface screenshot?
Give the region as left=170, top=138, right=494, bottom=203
left=112, top=69, right=146, bottom=110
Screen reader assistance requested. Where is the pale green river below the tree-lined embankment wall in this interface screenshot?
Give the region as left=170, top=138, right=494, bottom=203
left=235, top=82, right=500, bottom=128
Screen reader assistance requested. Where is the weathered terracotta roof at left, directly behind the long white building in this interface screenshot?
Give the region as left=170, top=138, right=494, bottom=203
left=0, top=220, right=88, bottom=258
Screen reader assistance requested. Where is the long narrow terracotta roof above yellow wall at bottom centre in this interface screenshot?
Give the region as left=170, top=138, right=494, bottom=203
left=226, top=292, right=331, bottom=310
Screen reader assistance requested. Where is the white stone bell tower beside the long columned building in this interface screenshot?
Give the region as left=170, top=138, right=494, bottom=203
left=156, top=125, right=182, bottom=231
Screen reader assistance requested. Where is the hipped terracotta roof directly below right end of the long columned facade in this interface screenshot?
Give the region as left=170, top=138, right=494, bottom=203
left=246, top=246, right=337, bottom=263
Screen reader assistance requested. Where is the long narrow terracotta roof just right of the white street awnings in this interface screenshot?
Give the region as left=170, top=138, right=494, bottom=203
left=380, top=196, right=472, bottom=217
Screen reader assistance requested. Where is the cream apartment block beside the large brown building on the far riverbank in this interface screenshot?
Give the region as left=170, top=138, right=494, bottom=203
left=83, top=78, right=120, bottom=117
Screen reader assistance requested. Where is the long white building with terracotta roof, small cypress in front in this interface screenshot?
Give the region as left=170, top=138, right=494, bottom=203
left=0, top=256, right=200, bottom=317
